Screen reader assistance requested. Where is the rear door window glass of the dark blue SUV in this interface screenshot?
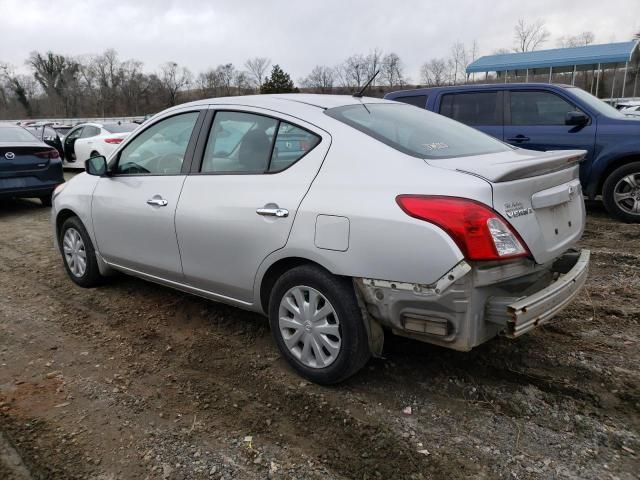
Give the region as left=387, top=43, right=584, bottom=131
left=440, top=92, right=502, bottom=125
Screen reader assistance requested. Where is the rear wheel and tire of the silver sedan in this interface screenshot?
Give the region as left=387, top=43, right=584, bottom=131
left=269, top=265, right=371, bottom=385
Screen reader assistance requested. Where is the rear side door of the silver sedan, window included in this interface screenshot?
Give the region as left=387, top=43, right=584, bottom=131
left=176, top=107, right=331, bottom=303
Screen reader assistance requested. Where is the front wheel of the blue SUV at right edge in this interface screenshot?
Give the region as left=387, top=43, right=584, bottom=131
left=602, top=162, right=640, bottom=223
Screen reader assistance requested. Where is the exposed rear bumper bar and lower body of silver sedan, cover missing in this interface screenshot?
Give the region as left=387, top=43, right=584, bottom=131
left=354, top=250, right=590, bottom=351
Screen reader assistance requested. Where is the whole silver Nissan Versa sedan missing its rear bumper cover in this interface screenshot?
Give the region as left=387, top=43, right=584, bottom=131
left=52, top=95, right=589, bottom=384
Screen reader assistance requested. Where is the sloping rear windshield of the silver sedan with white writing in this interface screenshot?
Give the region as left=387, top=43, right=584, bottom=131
left=325, top=103, right=511, bottom=159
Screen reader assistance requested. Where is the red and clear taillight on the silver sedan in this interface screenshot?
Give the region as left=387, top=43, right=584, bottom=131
left=396, top=195, right=529, bottom=260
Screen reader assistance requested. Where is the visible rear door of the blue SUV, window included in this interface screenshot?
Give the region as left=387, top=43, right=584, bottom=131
left=437, top=90, right=504, bottom=140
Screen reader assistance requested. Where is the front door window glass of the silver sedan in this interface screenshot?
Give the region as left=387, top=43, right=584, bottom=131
left=116, top=112, right=199, bottom=175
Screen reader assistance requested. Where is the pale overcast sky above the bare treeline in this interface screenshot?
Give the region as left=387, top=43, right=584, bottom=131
left=0, top=0, right=640, bottom=81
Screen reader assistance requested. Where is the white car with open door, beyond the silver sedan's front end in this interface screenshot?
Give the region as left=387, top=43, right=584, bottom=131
left=62, top=122, right=139, bottom=169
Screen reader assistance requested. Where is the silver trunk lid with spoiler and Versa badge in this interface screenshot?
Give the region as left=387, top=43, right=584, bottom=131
left=427, top=149, right=585, bottom=263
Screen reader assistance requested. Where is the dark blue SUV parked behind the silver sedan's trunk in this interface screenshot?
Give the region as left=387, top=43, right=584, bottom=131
left=385, top=83, right=640, bottom=223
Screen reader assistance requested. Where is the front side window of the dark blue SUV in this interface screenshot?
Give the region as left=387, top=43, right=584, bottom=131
left=510, top=90, right=578, bottom=125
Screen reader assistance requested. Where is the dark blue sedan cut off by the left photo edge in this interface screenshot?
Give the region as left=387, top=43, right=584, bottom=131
left=0, top=125, right=64, bottom=206
